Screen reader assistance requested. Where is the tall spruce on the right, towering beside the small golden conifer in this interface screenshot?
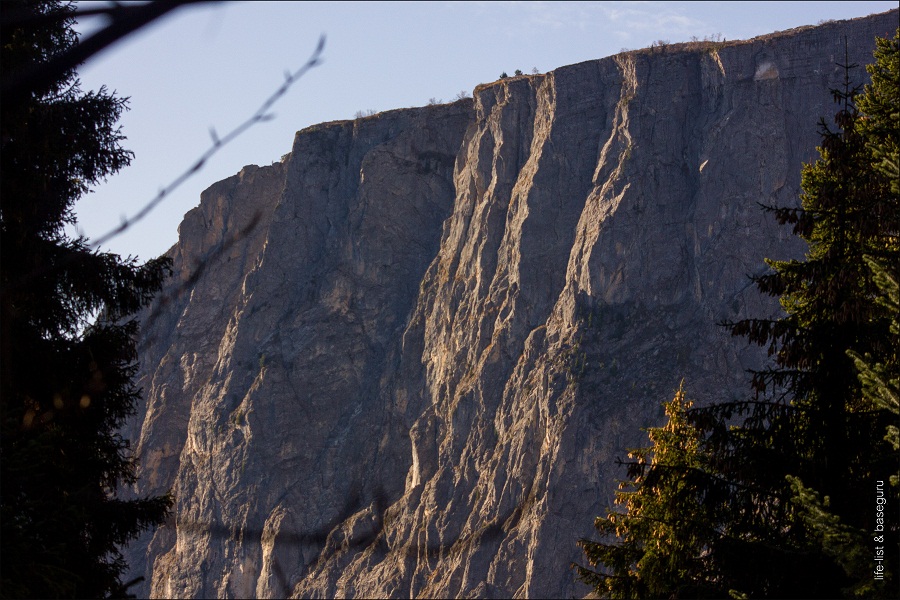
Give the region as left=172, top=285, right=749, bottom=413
left=692, top=31, right=900, bottom=597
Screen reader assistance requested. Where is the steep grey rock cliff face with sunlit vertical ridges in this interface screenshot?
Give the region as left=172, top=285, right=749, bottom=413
left=127, top=11, right=898, bottom=598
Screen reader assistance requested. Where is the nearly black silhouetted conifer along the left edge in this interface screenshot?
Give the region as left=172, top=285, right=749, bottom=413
left=0, top=0, right=171, bottom=598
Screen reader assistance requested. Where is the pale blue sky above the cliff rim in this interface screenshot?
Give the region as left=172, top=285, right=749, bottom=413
left=76, top=1, right=897, bottom=260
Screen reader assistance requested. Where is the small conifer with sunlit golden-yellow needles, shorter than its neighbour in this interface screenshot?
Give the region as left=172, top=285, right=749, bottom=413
left=575, top=382, right=715, bottom=598
